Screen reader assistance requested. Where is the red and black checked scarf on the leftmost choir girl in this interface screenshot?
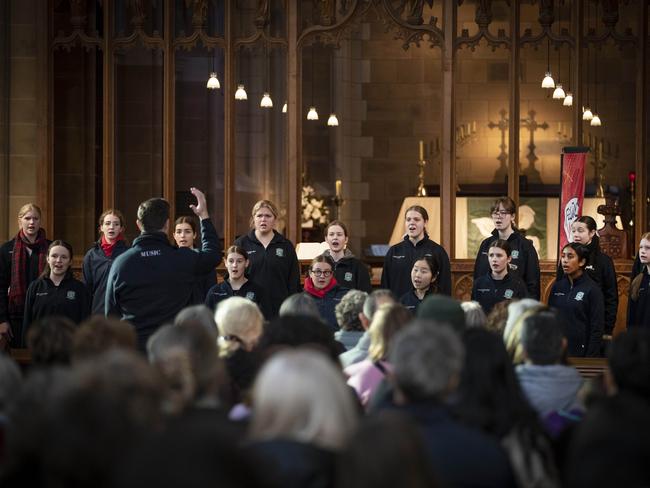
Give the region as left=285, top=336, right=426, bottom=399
left=9, top=229, right=48, bottom=317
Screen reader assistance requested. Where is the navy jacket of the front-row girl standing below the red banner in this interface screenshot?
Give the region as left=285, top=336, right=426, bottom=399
left=548, top=273, right=605, bottom=356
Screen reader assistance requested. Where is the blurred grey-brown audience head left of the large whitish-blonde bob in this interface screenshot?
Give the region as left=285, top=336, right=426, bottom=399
left=147, top=323, right=225, bottom=413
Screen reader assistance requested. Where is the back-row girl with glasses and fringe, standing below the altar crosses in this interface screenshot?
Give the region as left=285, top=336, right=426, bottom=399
left=474, top=197, right=540, bottom=300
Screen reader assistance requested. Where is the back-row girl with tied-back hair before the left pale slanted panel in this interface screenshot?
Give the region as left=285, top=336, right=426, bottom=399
left=381, top=205, right=451, bottom=297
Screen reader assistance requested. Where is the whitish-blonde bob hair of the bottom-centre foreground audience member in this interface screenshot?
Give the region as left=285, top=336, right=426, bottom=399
left=250, top=349, right=358, bottom=449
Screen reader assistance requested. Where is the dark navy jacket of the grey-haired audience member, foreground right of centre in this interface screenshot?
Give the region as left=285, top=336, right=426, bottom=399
left=398, top=402, right=516, bottom=488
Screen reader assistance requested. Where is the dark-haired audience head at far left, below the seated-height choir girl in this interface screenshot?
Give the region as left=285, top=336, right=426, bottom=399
left=27, top=315, right=75, bottom=366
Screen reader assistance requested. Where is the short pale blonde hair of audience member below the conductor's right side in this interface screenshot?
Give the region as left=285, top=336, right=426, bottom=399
left=214, top=297, right=264, bottom=357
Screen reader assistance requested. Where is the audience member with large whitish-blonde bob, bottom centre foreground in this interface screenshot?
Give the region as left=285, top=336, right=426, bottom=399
left=250, top=349, right=357, bottom=487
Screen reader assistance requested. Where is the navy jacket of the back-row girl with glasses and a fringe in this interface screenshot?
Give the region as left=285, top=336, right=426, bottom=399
left=474, top=229, right=540, bottom=300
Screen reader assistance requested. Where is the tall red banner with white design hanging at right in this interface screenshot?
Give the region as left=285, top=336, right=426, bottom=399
left=558, top=148, right=589, bottom=255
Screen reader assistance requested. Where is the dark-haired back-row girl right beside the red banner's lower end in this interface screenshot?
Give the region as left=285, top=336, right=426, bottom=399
left=557, top=215, right=618, bottom=336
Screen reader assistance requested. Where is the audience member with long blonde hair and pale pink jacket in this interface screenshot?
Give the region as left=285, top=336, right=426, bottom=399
left=345, top=303, right=412, bottom=406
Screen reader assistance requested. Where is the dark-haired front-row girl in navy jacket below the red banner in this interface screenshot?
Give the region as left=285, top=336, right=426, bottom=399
left=548, top=242, right=605, bottom=356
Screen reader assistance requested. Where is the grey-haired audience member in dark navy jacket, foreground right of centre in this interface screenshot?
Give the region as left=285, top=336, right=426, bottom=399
left=390, top=320, right=515, bottom=487
